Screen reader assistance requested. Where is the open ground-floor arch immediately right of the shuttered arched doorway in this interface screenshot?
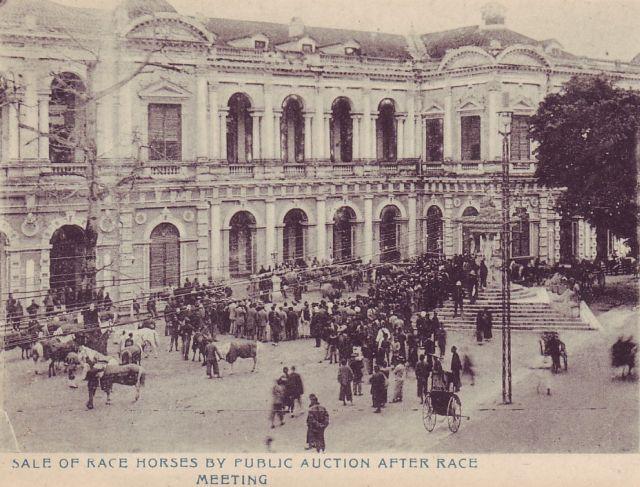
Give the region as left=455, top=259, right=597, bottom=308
left=229, top=211, right=256, bottom=277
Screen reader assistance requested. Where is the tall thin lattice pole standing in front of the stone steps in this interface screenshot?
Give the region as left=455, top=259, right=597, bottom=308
left=498, top=111, right=513, bottom=404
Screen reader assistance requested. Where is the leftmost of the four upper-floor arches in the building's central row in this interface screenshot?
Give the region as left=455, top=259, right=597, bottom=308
left=227, top=93, right=253, bottom=164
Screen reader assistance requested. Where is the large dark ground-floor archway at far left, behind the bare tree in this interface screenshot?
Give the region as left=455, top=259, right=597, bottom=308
left=49, top=225, right=87, bottom=290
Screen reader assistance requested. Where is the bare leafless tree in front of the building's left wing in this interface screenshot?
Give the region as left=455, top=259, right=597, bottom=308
left=0, top=26, right=184, bottom=302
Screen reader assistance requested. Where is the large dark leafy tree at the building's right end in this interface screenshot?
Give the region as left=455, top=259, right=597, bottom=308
left=531, top=75, right=640, bottom=258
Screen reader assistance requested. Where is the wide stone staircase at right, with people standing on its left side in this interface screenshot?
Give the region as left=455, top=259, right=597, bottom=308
left=437, top=284, right=592, bottom=332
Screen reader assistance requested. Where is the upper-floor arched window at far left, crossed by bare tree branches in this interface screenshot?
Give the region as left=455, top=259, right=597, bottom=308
left=49, top=73, right=86, bottom=163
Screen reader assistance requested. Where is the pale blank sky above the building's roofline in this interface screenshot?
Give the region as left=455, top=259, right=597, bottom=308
left=54, top=0, right=640, bottom=61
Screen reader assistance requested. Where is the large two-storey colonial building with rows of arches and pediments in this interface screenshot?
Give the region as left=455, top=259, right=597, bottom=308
left=0, top=0, right=640, bottom=300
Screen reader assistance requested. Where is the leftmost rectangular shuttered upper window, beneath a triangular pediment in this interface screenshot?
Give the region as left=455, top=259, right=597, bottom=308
left=149, top=103, right=182, bottom=161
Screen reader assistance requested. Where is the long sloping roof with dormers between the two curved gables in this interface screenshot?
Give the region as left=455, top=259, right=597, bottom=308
left=203, top=18, right=410, bottom=59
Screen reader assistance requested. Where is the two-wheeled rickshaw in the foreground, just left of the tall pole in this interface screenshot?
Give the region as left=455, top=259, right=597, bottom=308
left=422, top=357, right=462, bottom=433
